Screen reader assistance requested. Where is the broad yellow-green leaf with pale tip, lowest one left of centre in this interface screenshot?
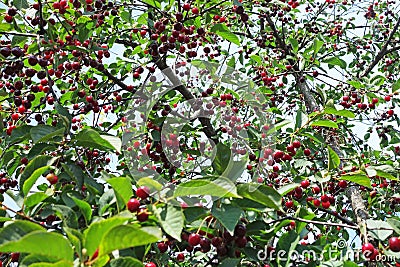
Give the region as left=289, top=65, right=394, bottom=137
left=99, top=225, right=162, bottom=257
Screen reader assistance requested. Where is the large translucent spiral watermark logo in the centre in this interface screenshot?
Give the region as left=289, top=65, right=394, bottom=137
left=122, top=61, right=274, bottom=206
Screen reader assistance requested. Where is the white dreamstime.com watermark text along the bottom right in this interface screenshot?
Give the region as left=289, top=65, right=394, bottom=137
left=257, top=239, right=397, bottom=262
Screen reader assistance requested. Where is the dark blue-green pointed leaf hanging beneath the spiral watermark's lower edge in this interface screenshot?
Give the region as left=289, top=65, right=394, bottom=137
left=211, top=204, right=242, bottom=235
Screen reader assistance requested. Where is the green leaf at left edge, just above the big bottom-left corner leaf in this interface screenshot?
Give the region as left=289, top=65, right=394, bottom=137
left=0, top=220, right=46, bottom=245
